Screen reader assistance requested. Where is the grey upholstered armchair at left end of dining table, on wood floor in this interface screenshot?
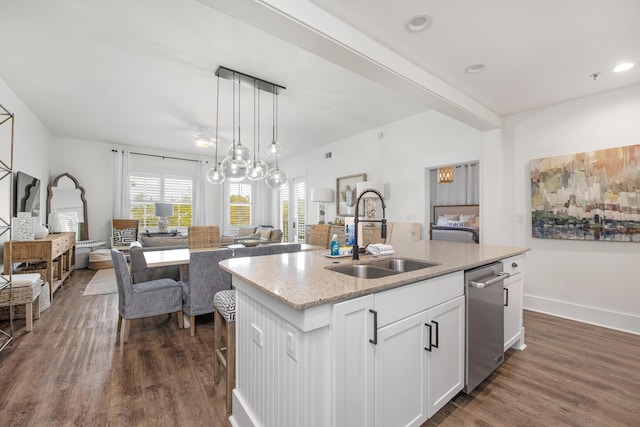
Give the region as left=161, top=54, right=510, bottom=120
left=111, top=249, right=182, bottom=343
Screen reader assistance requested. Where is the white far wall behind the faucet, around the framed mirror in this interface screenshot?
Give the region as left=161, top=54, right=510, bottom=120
left=280, top=110, right=484, bottom=238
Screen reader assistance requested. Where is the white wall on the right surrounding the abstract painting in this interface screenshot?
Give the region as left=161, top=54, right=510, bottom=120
left=504, top=85, right=640, bottom=333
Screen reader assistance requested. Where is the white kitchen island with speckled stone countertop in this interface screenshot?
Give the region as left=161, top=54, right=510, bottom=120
left=220, top=241, right=527, bottom=426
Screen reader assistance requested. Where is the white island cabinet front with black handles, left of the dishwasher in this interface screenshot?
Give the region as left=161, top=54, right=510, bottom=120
left=332, top=272, right=465, bottom=426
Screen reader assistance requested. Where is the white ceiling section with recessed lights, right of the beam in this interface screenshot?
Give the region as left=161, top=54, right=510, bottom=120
left=312, top=0, right=640, bottom=116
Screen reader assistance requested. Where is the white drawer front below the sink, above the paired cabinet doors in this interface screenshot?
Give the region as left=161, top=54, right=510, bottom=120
left=375, top=271, right=464, bottom=328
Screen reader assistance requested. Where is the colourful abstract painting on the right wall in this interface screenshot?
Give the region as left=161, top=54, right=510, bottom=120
left=530, top=145, right=640, bottom=242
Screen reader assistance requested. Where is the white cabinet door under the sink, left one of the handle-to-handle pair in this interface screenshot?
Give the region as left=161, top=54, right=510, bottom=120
left=375, top=311, right=428, bottom=427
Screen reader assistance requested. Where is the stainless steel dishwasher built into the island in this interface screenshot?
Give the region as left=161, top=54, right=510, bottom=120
left=464, top=262, right=509, bottom=393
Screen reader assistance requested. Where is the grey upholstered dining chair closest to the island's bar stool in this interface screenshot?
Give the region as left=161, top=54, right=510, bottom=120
left=180, top=249, right=233, bottom=336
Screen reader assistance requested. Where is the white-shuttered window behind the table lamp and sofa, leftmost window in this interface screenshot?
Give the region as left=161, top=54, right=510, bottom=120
left=129, top=173, right=193, bottom=228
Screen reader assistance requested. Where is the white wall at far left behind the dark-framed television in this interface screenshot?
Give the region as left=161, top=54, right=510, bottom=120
left=0, top=78, right=51, bottom=260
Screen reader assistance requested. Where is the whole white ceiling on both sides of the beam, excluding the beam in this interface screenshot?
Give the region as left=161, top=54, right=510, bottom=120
left=0, top=0, right=640, bottom=160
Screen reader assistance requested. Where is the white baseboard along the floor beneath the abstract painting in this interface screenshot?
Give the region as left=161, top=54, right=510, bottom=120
left=524, top=295, right=640, bottom=335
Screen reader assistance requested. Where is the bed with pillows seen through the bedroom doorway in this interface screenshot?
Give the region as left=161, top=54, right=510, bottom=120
left=429, top=205, right=480, bottom=243
